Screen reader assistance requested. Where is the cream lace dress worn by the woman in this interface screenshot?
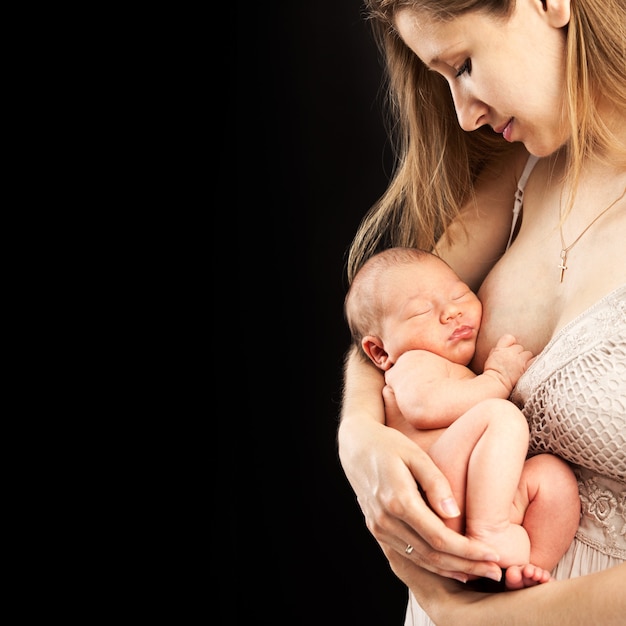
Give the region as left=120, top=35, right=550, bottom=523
left=405, top=285, right=626, bottom=626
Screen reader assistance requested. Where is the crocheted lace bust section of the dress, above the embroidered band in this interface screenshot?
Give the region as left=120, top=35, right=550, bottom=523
left=511, top=285, right=626, bottom=482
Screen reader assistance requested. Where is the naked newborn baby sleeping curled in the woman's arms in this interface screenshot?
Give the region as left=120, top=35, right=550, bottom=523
left=345, top=248, right=580, bottom=589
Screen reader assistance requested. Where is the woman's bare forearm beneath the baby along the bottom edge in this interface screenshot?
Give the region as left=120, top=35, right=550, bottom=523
left=383, top=546, right=626, bottom=626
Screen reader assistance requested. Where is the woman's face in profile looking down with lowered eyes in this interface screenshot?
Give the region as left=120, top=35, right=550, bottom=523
left=395, top=0, right=570, bottom=156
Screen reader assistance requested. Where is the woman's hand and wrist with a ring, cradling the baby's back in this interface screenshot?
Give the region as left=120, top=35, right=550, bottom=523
left=338, top=349, right=501, bottom=580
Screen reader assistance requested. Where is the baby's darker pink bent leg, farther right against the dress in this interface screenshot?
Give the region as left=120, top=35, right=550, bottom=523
left=506, top=454, right=580, bottom=589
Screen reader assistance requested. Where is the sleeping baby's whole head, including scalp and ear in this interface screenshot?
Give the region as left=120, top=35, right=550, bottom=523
left=344, top=247, right=482, bottom=370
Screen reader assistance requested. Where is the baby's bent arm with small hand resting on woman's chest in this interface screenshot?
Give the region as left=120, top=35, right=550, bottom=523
left=385, top=335, right=533, bottom=429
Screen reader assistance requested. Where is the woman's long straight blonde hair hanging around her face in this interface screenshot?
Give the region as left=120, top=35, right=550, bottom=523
left=347, top=0, right=626, bottom=282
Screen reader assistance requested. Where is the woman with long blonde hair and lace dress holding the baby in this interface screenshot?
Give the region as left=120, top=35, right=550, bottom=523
left=338, top=0, right=626, bottom=625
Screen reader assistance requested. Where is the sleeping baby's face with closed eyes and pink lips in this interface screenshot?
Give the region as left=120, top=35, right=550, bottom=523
left=383, top=257, right=482, bottom=365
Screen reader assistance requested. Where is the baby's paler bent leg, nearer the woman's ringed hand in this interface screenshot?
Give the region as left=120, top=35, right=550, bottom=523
left=429, top=399, right=530, bottom=568
